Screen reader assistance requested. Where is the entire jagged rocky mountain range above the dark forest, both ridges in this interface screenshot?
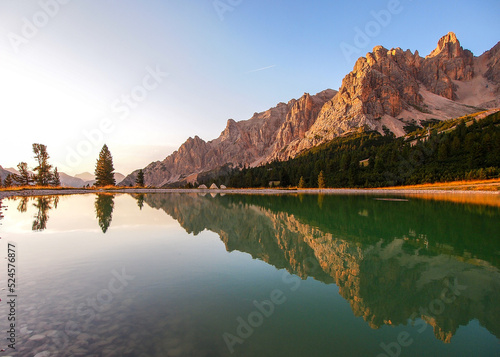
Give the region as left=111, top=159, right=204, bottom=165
left=122, top=33, right=500, bottom=186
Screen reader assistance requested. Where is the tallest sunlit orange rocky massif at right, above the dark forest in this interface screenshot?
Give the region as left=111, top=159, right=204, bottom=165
left=279, top=33, right=500, bottom=156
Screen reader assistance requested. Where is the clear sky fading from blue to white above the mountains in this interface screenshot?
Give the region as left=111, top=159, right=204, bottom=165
left=0, top=0, right=500, bottom=174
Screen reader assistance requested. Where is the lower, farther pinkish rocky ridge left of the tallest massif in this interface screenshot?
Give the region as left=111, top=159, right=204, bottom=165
left=122, top=89, right=336, bottom=186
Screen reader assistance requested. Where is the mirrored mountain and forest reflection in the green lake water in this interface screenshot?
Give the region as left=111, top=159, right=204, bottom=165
left=139, top=194, right=500, bottom=342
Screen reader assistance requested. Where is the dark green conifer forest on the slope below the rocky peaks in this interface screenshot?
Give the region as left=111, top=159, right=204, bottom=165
left=200, top=113, right=500, bottom=188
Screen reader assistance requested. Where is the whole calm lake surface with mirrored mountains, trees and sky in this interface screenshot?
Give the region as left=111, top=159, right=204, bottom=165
left=0, top=193, right=500, bottom=357
